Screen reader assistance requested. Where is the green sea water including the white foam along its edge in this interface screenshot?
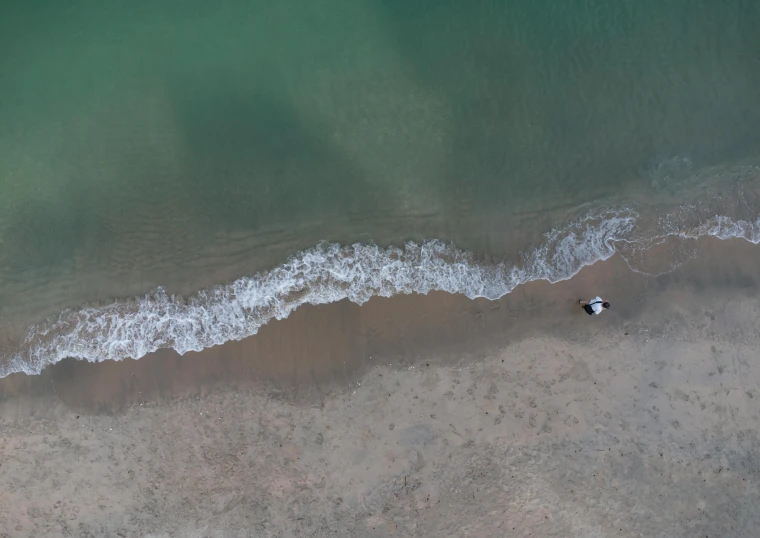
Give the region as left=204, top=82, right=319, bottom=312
left=0, top=0, right=760, bottom=372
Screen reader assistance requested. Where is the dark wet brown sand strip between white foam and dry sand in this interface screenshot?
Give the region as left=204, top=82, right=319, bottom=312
left=0, top=234, right=760, bottom=412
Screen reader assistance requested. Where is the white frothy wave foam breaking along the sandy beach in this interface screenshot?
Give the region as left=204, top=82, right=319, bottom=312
left=0, top=210, right=760, bottom=377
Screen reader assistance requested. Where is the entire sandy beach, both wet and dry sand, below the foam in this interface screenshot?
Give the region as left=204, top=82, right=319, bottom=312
left=0, top=241, right=760, bottom=537
